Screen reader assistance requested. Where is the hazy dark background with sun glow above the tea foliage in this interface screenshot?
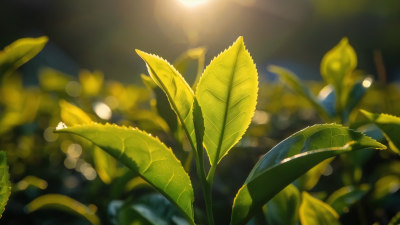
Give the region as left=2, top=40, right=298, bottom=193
left=0, top=0, right=400, bottom=83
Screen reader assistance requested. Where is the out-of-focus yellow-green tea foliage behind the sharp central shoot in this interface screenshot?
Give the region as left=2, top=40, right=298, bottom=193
left=0, top=35, right=400, bottom=225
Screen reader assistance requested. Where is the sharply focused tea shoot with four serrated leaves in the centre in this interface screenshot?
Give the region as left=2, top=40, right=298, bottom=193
left=57, top=38, right=385, bottom=224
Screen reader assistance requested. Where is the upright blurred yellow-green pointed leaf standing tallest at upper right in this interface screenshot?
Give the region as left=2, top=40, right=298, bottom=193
left=321, top=38, right=357, bottom=98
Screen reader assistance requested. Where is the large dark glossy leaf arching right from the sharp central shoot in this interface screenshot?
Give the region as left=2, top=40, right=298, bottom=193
left=231, top=124, right=386, bottom=225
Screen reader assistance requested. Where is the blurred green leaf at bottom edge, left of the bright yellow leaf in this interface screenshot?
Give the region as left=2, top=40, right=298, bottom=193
left=266, top=184, right=301, bottom=225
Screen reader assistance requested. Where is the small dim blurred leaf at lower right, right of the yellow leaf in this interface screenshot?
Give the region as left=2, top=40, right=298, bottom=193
left=326, top=184, right=370, bottom=215
